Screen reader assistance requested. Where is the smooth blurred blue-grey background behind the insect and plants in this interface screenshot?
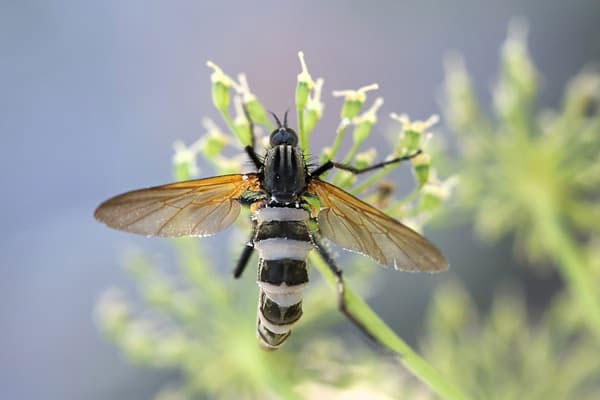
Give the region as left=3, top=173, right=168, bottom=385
left=0, top=0, right=600, bottom=399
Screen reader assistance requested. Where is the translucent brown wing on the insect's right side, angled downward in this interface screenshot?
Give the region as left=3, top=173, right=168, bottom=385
left=307, top=179, right=448, bottom=272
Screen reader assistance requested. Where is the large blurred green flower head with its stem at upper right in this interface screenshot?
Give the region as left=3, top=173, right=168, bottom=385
left=446, top=21, right=600, bottom=337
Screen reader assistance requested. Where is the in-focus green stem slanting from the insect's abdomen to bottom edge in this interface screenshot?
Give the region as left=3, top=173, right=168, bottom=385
left=310, top=253, right=467, bottom=399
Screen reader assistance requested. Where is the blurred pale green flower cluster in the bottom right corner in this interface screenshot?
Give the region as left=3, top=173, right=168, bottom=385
left=422, top=283, right=600, bottom=400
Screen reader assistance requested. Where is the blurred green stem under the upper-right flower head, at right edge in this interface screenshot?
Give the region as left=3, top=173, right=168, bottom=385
left=538, top=215, right=600, bottom=338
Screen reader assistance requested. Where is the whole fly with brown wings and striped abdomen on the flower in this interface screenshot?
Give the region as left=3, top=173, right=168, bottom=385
left=94, top=113, right=447, bottom=350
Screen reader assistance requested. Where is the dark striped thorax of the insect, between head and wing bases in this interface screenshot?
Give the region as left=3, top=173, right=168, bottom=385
left=263, top=144, right=307, bottom=204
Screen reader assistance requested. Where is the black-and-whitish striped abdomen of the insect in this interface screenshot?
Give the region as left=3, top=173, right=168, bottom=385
left=254, top=207, right=312, bottom=350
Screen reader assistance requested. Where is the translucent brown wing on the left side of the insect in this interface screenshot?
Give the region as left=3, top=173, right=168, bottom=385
left=94, top=174, right=259, bottom=237
